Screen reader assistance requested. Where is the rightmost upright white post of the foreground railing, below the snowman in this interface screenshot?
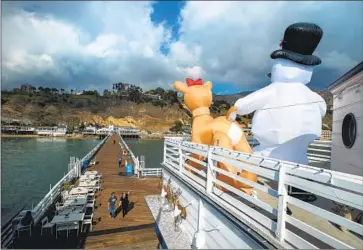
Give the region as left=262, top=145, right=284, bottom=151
left=276, top=163, right=287, bottom=242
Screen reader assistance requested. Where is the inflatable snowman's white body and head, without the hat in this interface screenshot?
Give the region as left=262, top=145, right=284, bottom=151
left=235, top=59, right=326, bottom=164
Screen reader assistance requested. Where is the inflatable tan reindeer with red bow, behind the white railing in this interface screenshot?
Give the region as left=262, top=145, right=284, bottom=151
left=174, top=78, right=257, bottom=195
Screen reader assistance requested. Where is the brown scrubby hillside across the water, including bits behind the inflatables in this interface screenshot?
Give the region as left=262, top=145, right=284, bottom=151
left=1, top=87, right=332, bottom=131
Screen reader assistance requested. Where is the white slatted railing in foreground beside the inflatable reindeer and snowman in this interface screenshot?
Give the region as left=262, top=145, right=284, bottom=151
left=163, top=138, right=363, bottom=249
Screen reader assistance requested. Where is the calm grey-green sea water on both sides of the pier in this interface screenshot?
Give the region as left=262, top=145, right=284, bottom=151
left=1, top=138, right=163, bottom=215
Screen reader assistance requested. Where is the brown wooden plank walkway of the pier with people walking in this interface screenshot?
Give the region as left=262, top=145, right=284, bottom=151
left=84, top=134, right=159, bottom=248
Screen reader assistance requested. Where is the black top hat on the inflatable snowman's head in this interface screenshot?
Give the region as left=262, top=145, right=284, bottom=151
left=271, top=23, right=323, bottom=66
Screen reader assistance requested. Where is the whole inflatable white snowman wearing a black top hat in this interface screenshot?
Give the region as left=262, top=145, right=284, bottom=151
left=231, top=23, right=326, bottom=164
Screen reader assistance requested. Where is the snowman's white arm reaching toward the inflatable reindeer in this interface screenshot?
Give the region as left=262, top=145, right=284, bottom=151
left=234, top=86, right=275, bottom=115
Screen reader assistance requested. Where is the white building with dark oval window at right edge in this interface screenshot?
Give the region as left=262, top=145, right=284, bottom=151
left=329, top=62, right=363, bottom=176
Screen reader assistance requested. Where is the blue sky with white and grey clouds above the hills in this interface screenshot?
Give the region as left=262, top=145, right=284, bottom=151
left=1, top=1, right=363, bottom=93
